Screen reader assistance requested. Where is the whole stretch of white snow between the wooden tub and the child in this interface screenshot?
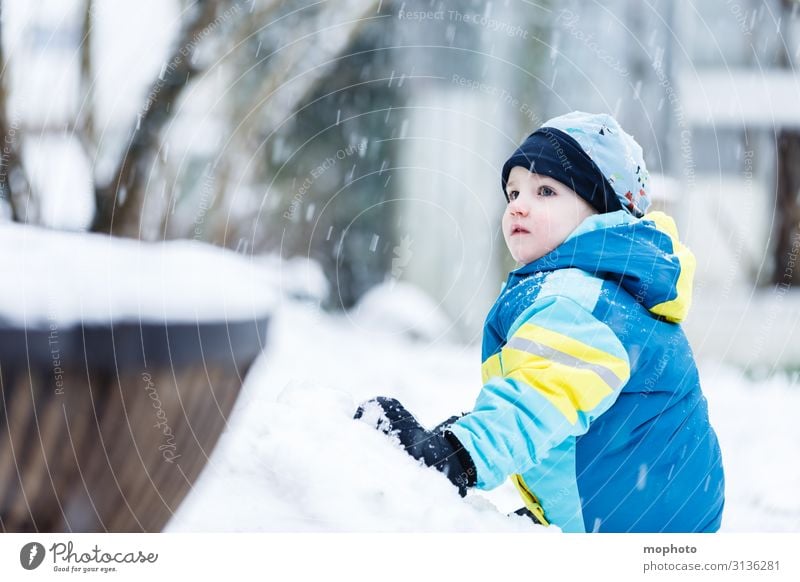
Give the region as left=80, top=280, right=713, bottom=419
left=167, top=301, right=544, bottom=532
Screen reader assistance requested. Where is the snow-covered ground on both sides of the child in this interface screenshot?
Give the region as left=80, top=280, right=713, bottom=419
left=167, top=284, right=800, bottom=532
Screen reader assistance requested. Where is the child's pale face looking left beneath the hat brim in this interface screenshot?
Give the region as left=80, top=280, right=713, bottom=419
left=503, top=166, right=597, bottom=264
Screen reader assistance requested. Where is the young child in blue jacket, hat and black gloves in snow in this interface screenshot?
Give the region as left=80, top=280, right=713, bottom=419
left=356, top=111, right=724, bottom=532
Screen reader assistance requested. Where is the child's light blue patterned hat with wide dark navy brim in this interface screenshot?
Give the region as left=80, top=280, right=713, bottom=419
left=502, top=111, right=650, bottom=218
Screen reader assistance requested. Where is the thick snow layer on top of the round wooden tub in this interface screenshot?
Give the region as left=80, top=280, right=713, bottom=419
left=0, top=224, right=275, bottom=325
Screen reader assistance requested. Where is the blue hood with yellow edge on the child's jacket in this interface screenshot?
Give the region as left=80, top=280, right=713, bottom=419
left=506, top=210, right=695, bottom=323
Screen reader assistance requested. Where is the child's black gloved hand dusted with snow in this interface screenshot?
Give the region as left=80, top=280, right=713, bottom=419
left=354, top=396, right=476, bottom=497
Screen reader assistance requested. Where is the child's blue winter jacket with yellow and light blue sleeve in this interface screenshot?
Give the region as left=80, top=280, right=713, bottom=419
left=451, top=210, right=724, bottom=532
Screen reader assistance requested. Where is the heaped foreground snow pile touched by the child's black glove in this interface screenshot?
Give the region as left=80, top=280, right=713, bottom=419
left=171, top=384, right=542, bottom=531
